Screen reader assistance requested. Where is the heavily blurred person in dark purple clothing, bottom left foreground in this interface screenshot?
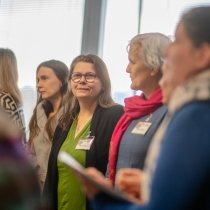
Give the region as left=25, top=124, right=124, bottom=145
left=0, top=108, right=45, bottom=210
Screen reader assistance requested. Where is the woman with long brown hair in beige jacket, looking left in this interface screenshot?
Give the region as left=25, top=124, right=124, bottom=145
left=28, top=60, right=69, bottom=188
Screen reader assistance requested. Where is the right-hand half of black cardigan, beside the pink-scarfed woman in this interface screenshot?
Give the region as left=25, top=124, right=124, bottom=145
left=86, top=105, right=124, bottom=174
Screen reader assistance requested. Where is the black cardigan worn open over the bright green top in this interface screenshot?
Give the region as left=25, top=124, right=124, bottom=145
left=43, top=105, right=124, bottom=210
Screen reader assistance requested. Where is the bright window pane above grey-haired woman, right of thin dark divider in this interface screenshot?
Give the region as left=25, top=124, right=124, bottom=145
left=140, top=0, right=210, bottom=35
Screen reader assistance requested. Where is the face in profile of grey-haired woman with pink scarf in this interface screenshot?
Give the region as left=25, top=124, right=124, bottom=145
left=126, top=43, right=152, bottom=92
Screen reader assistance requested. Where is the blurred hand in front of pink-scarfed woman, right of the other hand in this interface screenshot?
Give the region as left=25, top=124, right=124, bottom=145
left=115, top=168, right=142, bottom=202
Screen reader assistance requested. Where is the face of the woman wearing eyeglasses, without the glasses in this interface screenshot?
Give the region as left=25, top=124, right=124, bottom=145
left=70, top=62, right=102, bottom=101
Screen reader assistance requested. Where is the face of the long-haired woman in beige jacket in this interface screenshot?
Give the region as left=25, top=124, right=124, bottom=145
left=37, top=66, right=62, bottom=102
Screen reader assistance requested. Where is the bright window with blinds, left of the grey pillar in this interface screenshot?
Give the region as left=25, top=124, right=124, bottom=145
left=0, top=0, right=84, bottom=129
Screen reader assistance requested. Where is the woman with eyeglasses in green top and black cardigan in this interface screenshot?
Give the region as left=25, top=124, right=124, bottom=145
left=44, top=54, right=124, bottom=210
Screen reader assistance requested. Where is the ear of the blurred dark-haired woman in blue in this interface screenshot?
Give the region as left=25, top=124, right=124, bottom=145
left=196, top=43, right=210, bottom=70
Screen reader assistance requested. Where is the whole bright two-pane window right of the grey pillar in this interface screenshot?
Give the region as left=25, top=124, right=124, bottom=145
left=102, top=0, right=210, bottom=104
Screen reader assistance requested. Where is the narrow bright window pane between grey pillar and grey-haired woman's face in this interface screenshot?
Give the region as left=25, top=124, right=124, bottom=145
left=102, top=0, right=139, bottom=104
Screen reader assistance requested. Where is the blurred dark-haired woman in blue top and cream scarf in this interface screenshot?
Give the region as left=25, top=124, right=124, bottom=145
left=78, top=7, right=210, bottom=210
